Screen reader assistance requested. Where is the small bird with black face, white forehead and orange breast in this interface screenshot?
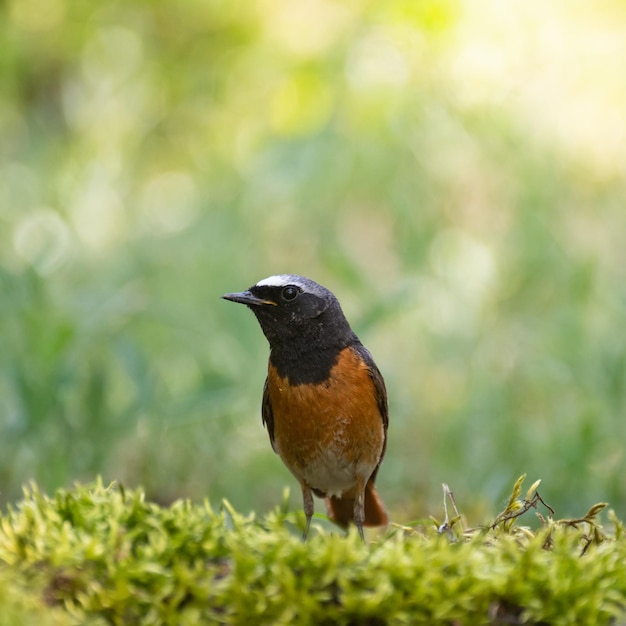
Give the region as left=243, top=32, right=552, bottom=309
left=222, top=274, right=389, bottom=541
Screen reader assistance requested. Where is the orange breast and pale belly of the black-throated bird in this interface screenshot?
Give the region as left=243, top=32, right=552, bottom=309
left=268, top=348, right=385, bottom=497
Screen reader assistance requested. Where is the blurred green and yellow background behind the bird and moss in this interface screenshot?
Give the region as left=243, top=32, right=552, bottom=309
left=0, top=0, right=626, bottom=522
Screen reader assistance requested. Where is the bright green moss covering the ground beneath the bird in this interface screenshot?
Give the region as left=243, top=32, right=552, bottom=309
left=0, top=481, right=626, bottom=625
